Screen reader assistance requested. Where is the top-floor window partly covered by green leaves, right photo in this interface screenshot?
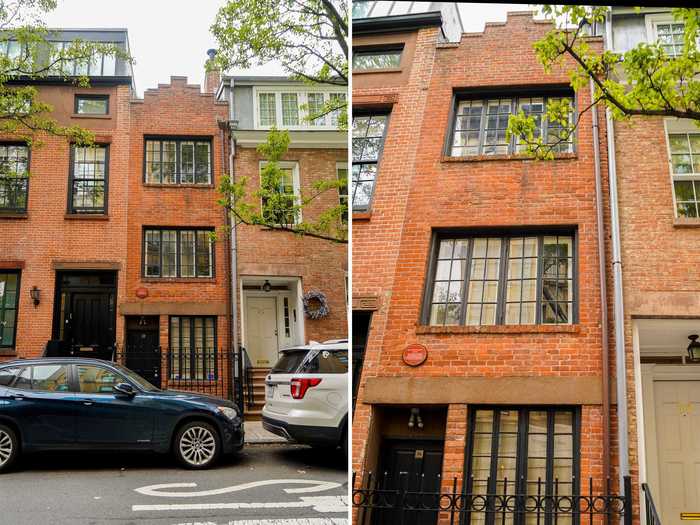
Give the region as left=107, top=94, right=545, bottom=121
left=451, top=97, right=574, bottom=157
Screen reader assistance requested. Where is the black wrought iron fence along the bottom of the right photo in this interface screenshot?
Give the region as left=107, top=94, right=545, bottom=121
left=352, top=472, right=632, bottom=525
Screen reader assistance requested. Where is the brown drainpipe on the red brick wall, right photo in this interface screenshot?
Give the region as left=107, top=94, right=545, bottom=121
left=589, top=75, right=610, bottom=490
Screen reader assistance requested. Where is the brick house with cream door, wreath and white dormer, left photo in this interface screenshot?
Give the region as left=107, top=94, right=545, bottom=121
left=218, top=76, right=348, bottom=417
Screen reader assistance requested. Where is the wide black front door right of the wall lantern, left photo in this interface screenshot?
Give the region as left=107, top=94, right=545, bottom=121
left=54, top=271, right=117, bottom=359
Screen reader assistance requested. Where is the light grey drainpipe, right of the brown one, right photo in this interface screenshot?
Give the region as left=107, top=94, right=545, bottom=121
left=605, top=11, right=630, bottom=491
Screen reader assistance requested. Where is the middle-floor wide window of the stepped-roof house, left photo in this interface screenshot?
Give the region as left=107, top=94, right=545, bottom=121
left=143, top=228, right=214, bottom=277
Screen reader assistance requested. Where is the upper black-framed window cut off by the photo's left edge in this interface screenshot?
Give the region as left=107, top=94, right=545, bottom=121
left=0, top=144, right=29, bottom=213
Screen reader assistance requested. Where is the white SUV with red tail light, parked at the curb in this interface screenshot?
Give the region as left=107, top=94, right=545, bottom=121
left=262, top=340, right=348, bottom=455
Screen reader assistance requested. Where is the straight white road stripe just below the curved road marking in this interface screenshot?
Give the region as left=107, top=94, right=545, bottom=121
left=131, top=496, right=349, bottom=513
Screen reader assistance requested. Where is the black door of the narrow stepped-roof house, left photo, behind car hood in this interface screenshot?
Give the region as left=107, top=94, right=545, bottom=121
left=124, top=316, right=161, bottom=388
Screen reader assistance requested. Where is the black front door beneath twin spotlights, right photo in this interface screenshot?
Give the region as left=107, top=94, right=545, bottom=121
left=372, top=440, right=444, bottom=525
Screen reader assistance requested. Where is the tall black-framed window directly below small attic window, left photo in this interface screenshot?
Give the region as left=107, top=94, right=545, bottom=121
left=68, top=145, right=109, bottom=213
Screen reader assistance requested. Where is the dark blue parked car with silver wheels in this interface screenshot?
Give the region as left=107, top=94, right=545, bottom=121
left=0, top=358, right=244, bottom=472
